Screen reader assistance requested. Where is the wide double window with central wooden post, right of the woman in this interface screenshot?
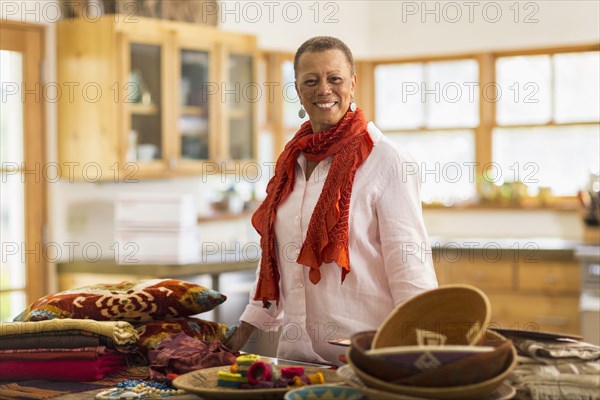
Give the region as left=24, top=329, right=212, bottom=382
left=370, top=45, right=600, bottom=205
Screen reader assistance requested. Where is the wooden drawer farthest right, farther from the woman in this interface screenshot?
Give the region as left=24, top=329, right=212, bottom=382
left=518, top=261, right=581, bottom=293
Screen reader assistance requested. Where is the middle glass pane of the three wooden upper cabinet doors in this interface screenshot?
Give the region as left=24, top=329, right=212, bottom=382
left=178, top=49, right=210, bottom=160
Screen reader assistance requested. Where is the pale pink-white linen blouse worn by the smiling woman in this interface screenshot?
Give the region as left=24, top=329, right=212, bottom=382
left=240, top=122, right=437, bottom=364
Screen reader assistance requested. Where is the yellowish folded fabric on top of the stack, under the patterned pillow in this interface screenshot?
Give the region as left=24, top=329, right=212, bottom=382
left=0, top=319, right=139, bottom=345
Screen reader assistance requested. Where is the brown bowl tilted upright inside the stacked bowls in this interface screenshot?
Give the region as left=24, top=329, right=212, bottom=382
left=372, top=285, right=491, bottom=349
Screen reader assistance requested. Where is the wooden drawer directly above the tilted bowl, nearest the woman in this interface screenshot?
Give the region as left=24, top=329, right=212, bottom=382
left=447, top=260, right=513, bottom=291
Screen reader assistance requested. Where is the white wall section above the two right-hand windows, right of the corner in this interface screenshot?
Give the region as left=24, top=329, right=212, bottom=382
left=369, top=0, right=600, bottom=57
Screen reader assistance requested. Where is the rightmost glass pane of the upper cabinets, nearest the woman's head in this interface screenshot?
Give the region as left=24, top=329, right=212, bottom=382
left=225, top=54, right=252, bottom=160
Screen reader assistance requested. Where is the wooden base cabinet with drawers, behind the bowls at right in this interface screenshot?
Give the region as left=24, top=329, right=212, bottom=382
left=434, top=249, right=580, bottom=334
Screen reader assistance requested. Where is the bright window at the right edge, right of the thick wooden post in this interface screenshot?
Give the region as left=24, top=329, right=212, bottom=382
left=492, top=52, right=600, bottom=196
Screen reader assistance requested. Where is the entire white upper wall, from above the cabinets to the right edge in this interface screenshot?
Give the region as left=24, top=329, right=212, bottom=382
left=220, top=0, right=600, bottom=58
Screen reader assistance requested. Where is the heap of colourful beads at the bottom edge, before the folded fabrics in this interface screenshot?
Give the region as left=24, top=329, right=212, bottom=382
left=96, top=379, right=185, bottom=400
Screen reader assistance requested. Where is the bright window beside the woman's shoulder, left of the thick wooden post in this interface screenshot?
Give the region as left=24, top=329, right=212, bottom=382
left=375, top=59, right=479, bottom=205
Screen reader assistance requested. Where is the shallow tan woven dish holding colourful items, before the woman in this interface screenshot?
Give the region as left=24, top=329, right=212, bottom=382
left=173, top=365, right=344, bottom=400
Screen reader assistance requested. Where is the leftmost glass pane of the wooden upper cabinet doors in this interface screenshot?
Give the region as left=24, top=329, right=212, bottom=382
left=125, top=43, right=164, bottom=162
